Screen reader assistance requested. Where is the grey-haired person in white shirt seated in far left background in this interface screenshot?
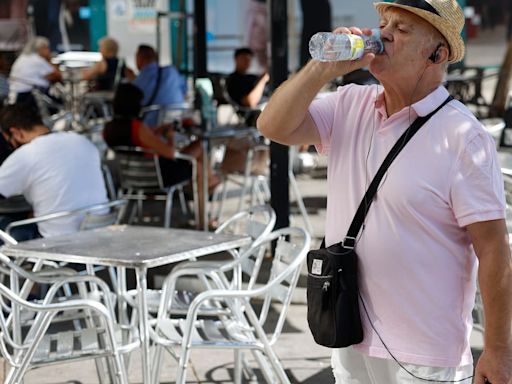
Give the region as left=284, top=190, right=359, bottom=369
left=9, top=36, right=62, bottom=106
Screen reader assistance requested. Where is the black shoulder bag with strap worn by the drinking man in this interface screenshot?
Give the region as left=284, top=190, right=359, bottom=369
left=307, top=96, right=453, bottom=348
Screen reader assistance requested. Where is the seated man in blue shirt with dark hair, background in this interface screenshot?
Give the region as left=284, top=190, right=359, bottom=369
left=133, top=44, right=187, bottom=127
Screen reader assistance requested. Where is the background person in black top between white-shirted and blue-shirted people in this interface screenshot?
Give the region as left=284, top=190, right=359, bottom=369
left=82, top=37, right=131, bottom=91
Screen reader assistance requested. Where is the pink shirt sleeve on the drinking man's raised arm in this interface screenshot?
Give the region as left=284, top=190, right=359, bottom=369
left=308, top=90, right=340, bottom=154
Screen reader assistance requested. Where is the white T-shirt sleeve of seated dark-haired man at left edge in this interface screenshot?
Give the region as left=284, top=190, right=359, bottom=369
left=0, top=148, right=29, bottom=197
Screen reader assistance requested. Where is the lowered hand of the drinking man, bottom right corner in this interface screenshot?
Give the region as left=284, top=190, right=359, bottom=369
left=475, top=347, right=512, bottom=384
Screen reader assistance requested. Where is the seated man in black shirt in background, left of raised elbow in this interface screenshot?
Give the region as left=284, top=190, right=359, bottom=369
left=226, top=48, right=269, bottom=108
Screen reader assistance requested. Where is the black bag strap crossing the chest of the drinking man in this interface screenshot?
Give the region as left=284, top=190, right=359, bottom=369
left=341, top=96, right=453, bottom=249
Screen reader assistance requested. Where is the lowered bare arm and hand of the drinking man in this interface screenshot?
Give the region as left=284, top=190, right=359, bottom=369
left=467, top=220, right=512, bottom=384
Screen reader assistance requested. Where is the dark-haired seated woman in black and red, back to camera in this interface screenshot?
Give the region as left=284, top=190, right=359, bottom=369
left=103, top=83, right=220, bottom=224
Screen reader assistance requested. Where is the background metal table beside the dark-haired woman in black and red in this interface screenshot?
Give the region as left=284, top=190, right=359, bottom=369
left=191, top=125, right=258, bottom=231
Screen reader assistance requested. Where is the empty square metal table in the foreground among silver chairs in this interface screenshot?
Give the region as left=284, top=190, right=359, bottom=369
left=1, top=225, right=251, bottom=383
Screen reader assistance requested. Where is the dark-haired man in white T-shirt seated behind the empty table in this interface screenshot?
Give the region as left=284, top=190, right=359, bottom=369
left=0, top=105, right=107, bottom=240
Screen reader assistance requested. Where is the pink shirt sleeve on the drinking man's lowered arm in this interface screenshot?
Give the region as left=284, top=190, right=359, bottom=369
left=450, top=132, right=506, bottom=227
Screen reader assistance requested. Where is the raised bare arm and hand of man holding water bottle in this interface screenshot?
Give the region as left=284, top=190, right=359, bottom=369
left=257, top=28, right=375, bottom=145
